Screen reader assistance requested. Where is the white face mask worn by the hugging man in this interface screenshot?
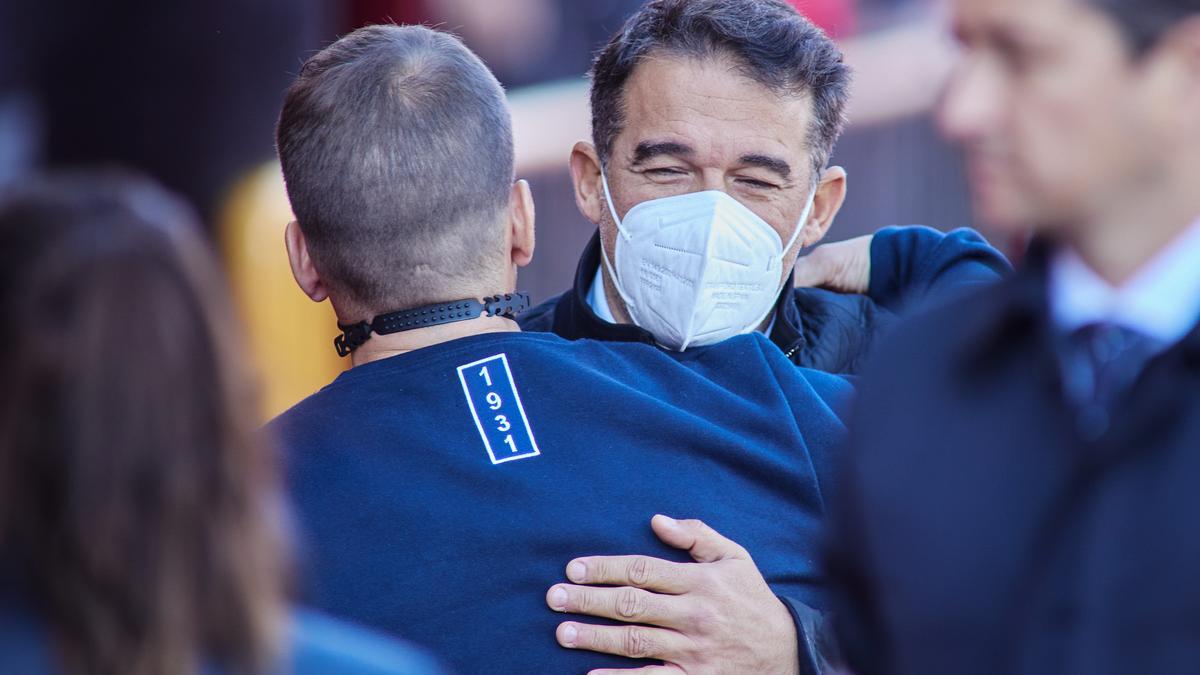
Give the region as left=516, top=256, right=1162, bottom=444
left=600, top=172, right=816, bottom=352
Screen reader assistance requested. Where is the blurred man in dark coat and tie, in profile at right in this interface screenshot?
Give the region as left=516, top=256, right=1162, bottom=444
left=830, top=0, right=1200, bottom=675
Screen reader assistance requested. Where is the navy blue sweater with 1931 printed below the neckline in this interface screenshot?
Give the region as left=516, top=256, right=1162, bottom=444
left=272, top=333, right=851, bottom=673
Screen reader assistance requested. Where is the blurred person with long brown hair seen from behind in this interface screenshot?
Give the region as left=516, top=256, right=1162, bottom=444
left=0, top=172, right=433, bottom=675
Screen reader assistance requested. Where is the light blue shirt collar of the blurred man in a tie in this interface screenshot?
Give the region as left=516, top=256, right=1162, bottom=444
left=1050, top=214, right=1200, bottom=347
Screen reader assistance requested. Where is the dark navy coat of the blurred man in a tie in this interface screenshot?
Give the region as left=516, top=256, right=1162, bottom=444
left=829, top=246, right=1200, bottom=675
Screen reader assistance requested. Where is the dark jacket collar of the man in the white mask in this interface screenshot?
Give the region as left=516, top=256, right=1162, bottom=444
left=554, top=229, right=805, bottom=358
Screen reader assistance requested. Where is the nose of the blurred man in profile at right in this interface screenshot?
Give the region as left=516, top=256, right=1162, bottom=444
left=937, top=59, right=1002, bottom=143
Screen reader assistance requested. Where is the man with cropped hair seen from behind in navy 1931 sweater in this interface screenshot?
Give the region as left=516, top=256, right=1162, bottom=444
left=271, top=26, right=851, bottom=673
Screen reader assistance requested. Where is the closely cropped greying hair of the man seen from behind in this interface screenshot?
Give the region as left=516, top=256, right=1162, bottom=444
left=276, top=25, right=514, bottom=312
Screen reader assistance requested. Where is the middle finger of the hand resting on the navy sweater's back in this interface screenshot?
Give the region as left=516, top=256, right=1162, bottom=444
left=546, top=584, right=691, bottom=628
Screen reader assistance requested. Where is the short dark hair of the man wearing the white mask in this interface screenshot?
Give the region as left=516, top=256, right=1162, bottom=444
left=590, top=0, right=850, bottom=176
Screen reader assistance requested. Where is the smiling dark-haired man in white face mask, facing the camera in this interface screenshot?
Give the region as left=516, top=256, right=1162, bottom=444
left=521, top=0, right=1008, bottom=374
